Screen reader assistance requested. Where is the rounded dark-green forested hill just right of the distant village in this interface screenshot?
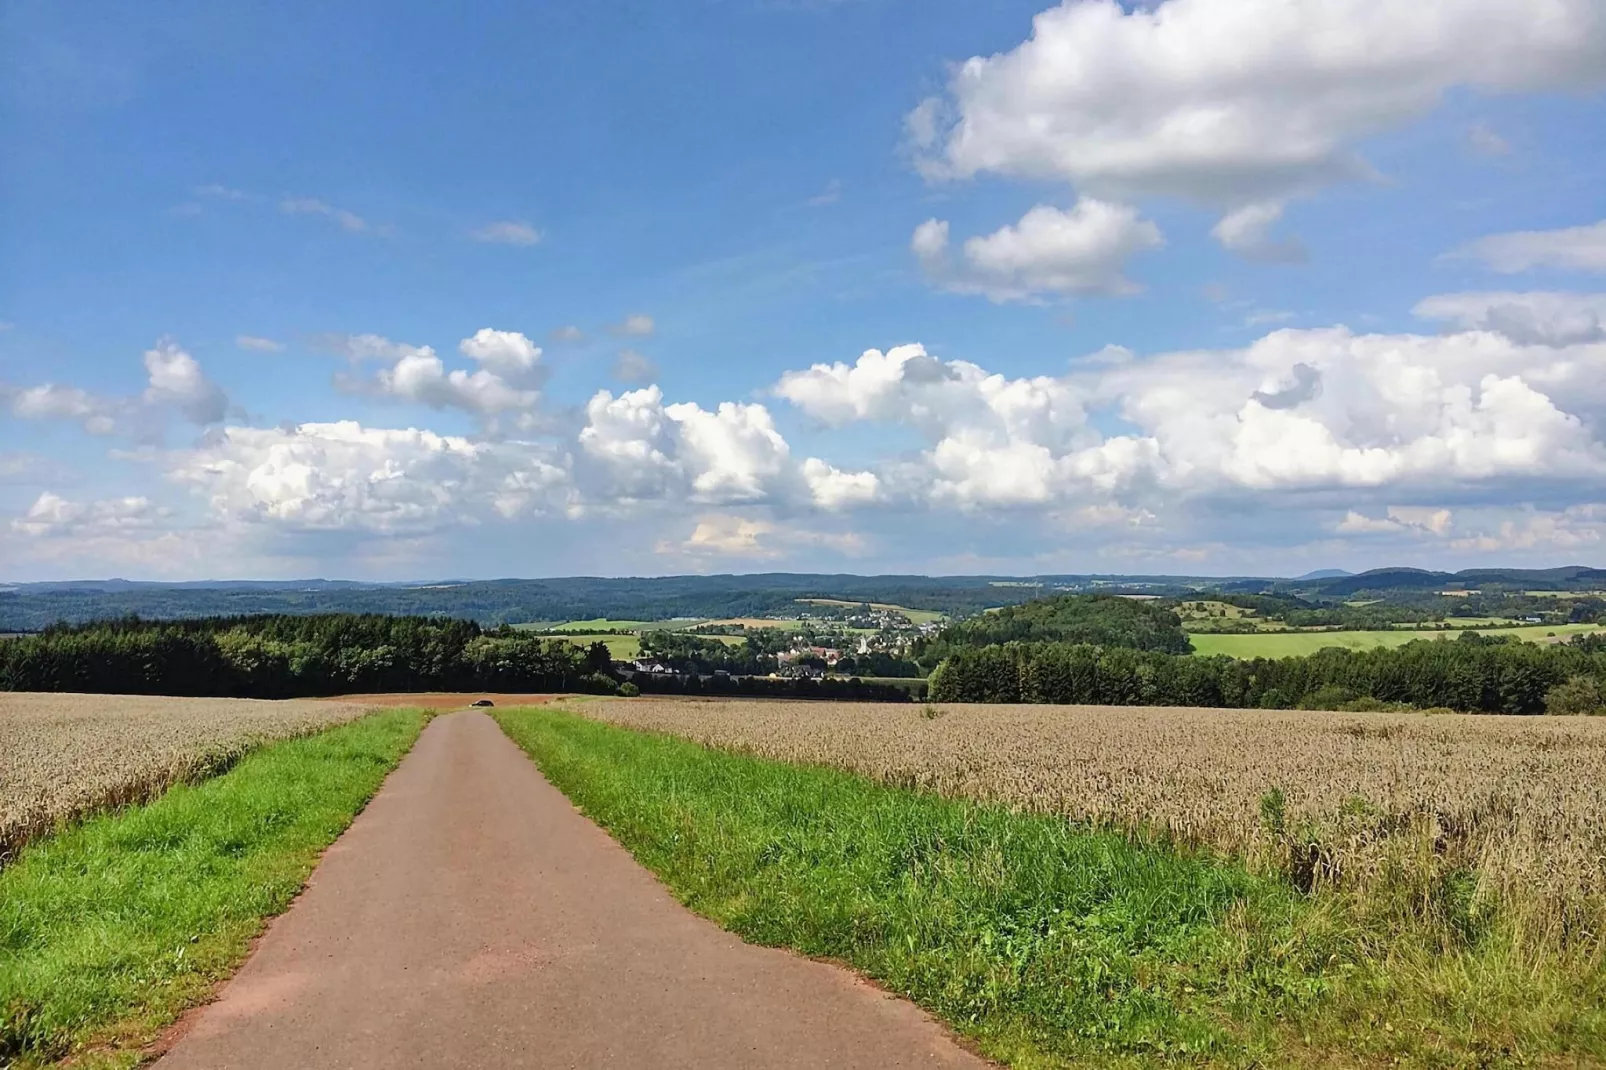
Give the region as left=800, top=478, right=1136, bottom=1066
left=917, top=594, right=1193, bottom=665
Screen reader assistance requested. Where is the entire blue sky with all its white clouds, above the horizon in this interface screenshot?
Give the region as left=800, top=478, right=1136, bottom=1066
left=0, top=0, right=1606, bottom=580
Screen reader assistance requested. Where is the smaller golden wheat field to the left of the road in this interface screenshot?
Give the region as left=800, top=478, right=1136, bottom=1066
left=0, top=692, right=366, bottom=858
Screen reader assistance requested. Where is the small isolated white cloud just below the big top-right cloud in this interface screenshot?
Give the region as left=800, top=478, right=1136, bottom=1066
left=909, top=198, right=1164, bottom=302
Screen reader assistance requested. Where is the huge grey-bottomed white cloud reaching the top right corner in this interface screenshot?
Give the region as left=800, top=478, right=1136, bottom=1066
left=907, top=0, right=1606, bottom=247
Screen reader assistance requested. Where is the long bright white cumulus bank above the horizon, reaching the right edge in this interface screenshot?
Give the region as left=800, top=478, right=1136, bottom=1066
left=776, top=328, right=1606, bottom=509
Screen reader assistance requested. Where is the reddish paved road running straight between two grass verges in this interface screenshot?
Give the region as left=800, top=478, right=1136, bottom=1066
left=157, top=712, right=988, bottom=1070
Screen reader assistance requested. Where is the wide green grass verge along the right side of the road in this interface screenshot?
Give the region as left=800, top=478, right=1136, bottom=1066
left=495, top=709, right=1601, bottom=1067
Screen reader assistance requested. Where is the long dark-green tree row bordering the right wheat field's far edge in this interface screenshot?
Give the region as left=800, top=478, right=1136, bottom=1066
left=930, top=633, right=1606, bottom=713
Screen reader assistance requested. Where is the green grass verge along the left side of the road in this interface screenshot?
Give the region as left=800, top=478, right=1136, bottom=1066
left=0, top=710, right=426, bottom=1067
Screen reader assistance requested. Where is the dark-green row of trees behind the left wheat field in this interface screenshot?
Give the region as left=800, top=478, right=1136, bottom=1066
left=0, top=614, right=615, bottom=699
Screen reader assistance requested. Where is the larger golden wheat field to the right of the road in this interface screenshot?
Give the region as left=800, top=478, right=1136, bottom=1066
left=587, top=699, right=1606, bottom=935
